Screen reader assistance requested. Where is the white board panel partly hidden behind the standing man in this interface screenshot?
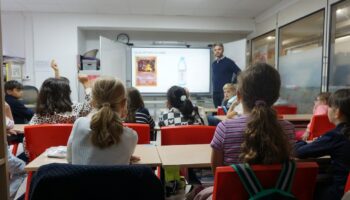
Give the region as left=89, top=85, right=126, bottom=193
left=224, top=39, right=247, bottom=70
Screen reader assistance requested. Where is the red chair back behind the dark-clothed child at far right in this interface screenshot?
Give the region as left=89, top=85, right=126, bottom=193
left=308, top=115, right=335, bottom=140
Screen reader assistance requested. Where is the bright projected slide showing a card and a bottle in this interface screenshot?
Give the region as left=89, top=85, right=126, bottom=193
left=131, top=48, right=210, bottom=93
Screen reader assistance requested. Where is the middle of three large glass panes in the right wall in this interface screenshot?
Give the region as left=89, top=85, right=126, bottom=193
left=278, top=10, right=324, bottom=113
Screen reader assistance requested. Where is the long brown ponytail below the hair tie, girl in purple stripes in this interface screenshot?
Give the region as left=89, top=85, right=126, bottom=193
left=240, top=103, right=291, bottom=164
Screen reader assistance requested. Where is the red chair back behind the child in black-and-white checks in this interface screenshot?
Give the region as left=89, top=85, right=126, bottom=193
left=160, top=125, right=216, bottom=145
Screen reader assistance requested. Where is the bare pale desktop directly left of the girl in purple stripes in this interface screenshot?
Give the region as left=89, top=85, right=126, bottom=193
left=157, top=144, right=211, bottom=167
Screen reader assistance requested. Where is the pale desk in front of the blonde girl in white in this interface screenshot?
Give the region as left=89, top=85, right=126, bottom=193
left=25, top=145, right=161, bottom=172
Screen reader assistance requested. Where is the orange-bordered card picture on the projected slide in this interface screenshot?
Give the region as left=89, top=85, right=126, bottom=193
left=135, top=56, right=157, bottom=86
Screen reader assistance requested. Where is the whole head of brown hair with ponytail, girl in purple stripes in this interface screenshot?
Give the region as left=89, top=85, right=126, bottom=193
left=238, top=63, right=292, bottom=164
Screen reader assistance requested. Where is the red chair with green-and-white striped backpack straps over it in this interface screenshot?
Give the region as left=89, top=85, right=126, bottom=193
left=213, top=162, right=318, bottom=200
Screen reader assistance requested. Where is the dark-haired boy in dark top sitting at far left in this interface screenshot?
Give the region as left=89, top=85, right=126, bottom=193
left=5, top=80, right=34, bottom=124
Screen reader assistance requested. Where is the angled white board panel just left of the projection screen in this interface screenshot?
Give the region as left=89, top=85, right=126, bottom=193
left=100, top=36, right=127, bottom=85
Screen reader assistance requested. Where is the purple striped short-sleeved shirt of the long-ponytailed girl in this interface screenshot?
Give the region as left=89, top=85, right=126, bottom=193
left=210, top=115, right=295, bottom=165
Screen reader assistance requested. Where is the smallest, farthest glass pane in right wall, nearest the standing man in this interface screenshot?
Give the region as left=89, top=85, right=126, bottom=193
left=252, top=31, right=276, bottom=66
